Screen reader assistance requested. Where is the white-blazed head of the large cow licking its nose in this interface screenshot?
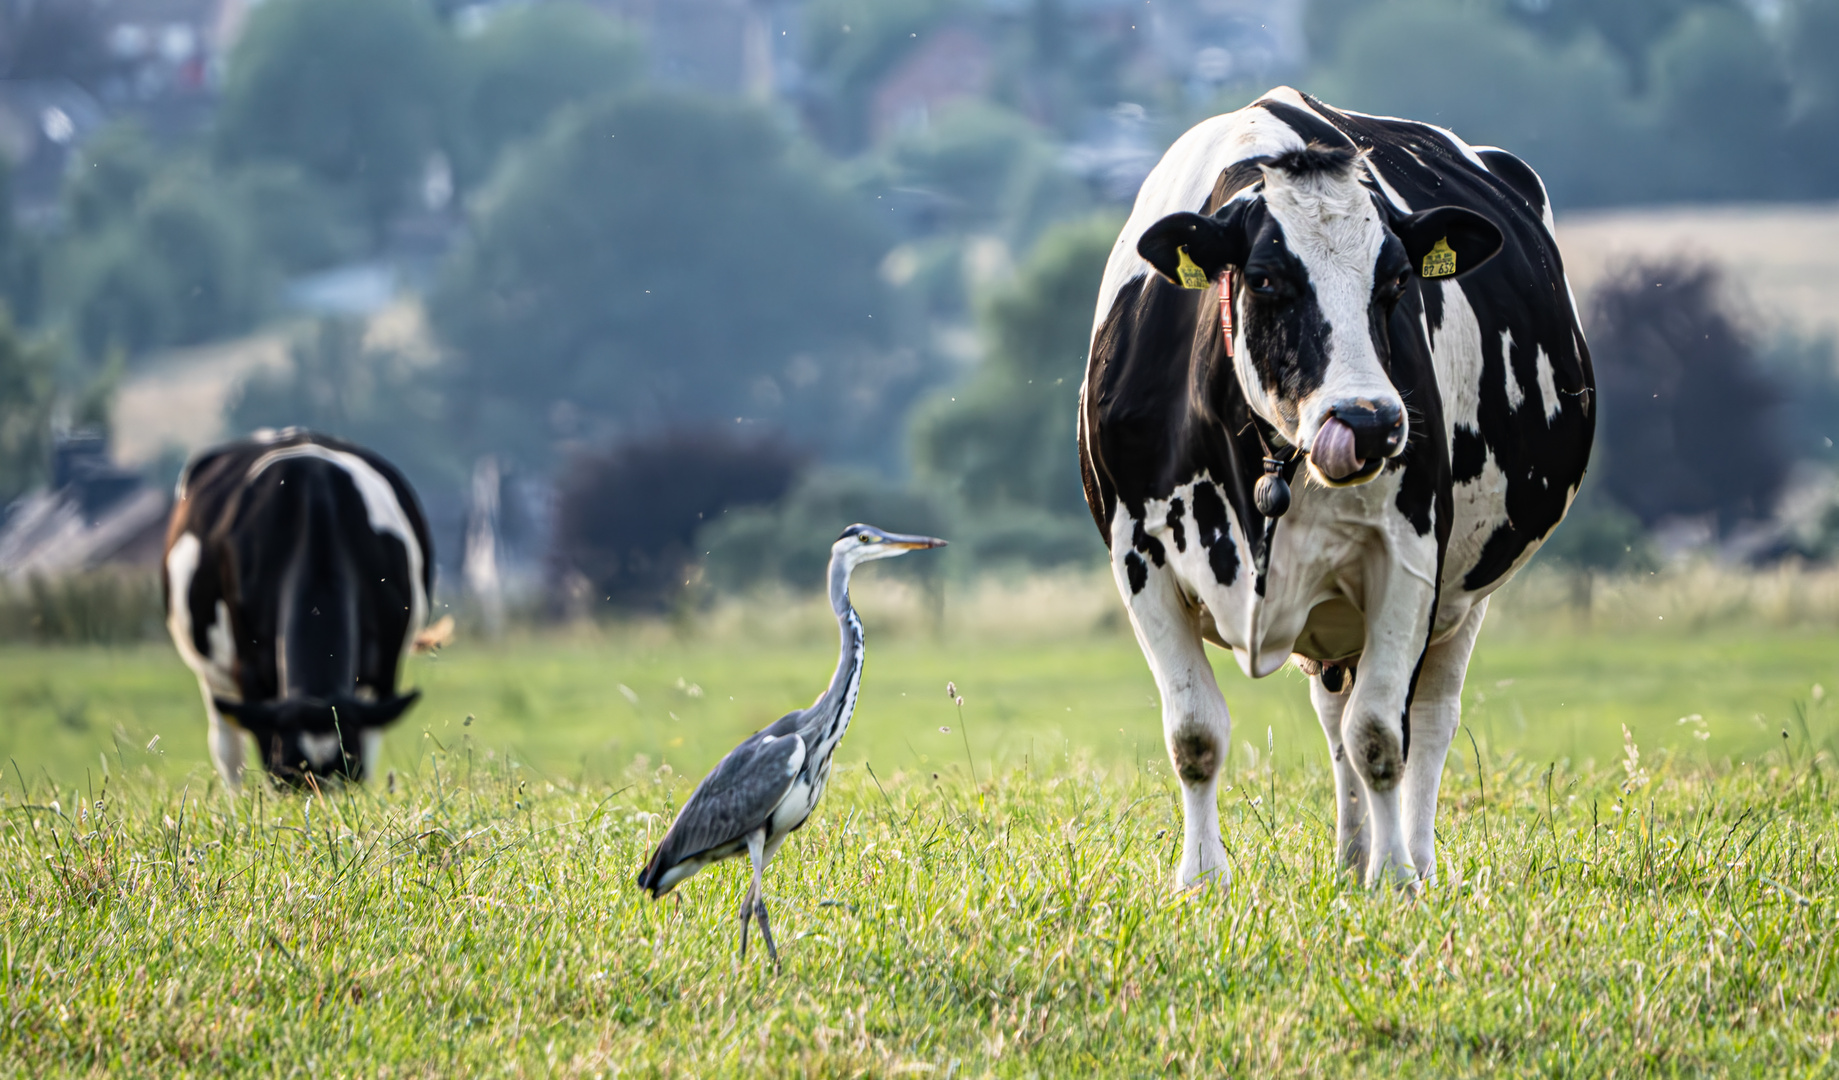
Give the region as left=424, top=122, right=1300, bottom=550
left=1137, top=145, right=1501, bottom=486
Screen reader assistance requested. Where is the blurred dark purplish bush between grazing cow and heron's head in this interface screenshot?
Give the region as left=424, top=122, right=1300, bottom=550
left=555, top=427, right=801, bottom=609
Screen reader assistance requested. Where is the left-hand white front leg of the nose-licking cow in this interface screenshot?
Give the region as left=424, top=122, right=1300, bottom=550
left=1113, top=548, right=1232, bottom=889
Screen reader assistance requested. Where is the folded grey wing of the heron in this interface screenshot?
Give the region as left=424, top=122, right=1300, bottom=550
left=653, top=723, right=805, bottom=868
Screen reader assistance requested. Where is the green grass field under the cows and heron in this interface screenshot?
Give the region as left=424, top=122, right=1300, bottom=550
left=0, top=570, right=1839, bottom=1076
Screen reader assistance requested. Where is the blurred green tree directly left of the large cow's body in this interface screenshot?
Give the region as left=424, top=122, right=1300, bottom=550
left=912, top=215, right=1120, bottom=523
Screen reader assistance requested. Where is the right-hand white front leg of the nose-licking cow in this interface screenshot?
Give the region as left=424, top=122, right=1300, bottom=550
left=1341, top=550, right=1442, bottom=885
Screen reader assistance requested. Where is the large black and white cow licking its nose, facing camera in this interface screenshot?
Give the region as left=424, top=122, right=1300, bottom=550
left=1079, top=86, right=1594, bottom=885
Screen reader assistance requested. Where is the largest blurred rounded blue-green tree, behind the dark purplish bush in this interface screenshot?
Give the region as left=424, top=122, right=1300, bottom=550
left=430, top=94, right=897, bottom=465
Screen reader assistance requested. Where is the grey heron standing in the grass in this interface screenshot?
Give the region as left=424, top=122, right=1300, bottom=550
left=638, top=524, right=945, bottom=966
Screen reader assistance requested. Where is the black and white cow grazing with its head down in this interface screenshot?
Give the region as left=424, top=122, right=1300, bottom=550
left=164, top=429, right=434, bottom=786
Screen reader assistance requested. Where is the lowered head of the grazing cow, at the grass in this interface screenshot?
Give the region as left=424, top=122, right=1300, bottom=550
left=215, top=690, right=421, bottom=786
